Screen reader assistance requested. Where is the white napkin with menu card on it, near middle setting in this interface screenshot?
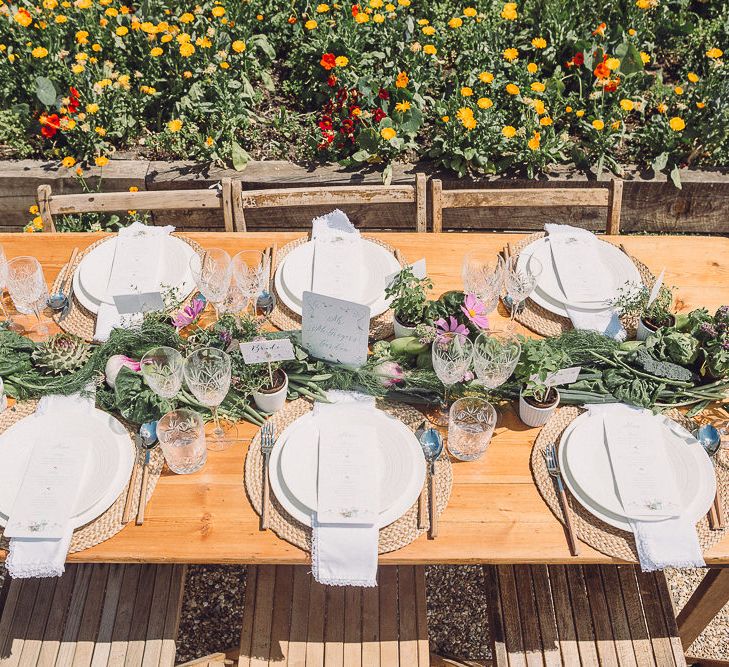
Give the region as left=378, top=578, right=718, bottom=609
left=311, top=391, right=379, bottom=587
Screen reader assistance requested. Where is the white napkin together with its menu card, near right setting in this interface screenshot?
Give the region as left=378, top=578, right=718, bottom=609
left=588, top=403, right=706, bottom=572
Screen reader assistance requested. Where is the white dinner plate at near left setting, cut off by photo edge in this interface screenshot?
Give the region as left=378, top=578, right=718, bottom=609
left=0, top=408, right=135, bottom=528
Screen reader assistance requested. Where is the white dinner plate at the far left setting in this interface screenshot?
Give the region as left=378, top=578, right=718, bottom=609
left=73, top=236, right=195, bottom=313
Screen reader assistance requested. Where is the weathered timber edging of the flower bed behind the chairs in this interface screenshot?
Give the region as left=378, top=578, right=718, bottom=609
left=0, top=160, right=729, bottom=234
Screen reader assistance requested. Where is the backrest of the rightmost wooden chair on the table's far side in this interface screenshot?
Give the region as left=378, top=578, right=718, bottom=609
left=430, top=178, right=623, bottom=234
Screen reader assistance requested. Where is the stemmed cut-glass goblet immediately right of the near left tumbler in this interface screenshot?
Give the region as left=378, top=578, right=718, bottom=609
left=184, top=347, right=237, bottom=451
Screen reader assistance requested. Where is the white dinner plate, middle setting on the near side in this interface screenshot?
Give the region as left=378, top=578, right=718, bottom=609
left=269, top=406, right=425, bottom=528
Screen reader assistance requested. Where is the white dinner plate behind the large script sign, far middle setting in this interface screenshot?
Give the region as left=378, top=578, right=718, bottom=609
left=274, top=239, right=401, bottom=317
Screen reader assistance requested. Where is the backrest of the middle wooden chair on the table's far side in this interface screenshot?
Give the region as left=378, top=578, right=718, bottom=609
left=226, top=174, right=427, bottom=232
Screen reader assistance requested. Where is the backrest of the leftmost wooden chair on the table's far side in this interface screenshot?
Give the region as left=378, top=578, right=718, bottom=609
left=37, top=178, right=233, bottom=232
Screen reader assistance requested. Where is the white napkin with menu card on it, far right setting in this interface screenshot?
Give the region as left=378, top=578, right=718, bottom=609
left=544, top=223, right=627, bottom=341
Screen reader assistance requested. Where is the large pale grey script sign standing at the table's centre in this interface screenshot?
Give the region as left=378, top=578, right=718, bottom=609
left=301, top=292, right=370, bottom=368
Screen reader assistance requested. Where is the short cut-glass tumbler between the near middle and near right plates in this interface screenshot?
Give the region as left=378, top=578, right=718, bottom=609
left=448, top=396, right=496, bottom=461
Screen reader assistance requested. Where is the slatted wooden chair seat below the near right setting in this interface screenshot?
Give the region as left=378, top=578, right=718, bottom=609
left=486, top=565, right=686, bottom=667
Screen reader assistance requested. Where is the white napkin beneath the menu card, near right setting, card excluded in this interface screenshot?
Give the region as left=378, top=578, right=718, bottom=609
left=588, top=403, right=706, bottom=572
